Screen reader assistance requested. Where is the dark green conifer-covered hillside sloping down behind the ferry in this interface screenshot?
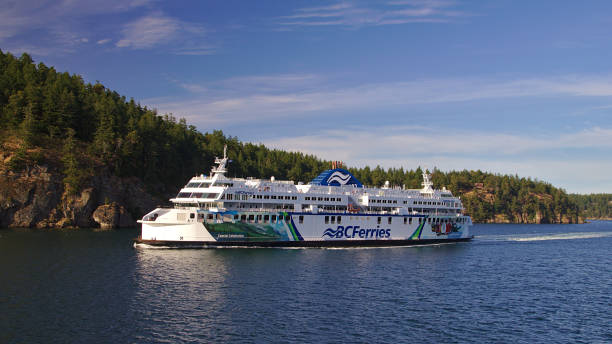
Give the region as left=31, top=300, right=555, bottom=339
left=0, top=51, right=579, bottom=226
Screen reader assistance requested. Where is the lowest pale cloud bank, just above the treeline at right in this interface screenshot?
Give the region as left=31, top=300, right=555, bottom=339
left=263, top=126, right=612, bottom=192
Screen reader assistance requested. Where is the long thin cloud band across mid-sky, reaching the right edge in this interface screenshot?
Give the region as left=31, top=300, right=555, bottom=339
left=149, top=75, right=612, bottom=124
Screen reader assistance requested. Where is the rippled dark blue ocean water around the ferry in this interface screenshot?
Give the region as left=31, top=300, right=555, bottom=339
left=0, top=221, right=612, bottom=343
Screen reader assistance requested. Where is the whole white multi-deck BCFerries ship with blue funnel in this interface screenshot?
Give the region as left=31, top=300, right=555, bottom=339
left=134, top=147, right=472, bottom=248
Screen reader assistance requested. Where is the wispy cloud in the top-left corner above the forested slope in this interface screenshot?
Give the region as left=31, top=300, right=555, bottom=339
left=0, top=0, right=215, bottom=55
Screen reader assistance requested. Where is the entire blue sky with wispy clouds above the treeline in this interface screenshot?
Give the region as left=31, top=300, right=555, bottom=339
left=0, top=0, right=612, bottom=193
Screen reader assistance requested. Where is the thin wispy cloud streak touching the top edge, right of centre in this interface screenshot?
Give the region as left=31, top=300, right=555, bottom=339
left=280, top=0, right=470, bottom=27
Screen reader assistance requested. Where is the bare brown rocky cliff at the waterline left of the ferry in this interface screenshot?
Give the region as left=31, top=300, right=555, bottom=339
left=0, top=145, right=165, bottom=229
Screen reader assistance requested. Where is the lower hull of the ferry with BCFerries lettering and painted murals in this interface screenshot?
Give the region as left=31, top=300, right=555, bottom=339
left=136, top=209, right=471, bottom=247
